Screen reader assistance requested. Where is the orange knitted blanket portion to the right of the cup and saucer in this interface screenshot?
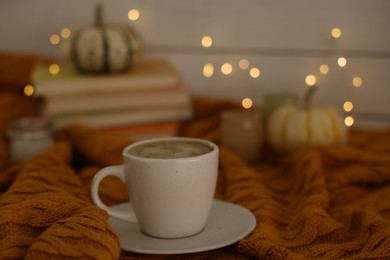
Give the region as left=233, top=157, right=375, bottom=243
left=185, top=105, right=390, bottom=259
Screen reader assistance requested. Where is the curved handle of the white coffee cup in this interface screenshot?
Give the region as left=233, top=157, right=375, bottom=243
left=91, top=165, right=138, bottom=223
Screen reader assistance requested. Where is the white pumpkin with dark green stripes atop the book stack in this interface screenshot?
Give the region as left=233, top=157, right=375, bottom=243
left=70, top=6, right=143, bottom=73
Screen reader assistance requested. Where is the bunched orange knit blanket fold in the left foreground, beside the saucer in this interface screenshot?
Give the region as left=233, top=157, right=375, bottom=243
left=0, top=133, right=119, bottom=259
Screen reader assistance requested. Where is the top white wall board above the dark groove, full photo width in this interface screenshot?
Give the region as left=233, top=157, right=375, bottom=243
left=0, top=0, right=390, bottom=54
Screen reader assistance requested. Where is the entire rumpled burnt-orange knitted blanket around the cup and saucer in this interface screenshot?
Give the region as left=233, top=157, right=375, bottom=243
left=0, top=53, right=390, bottom=259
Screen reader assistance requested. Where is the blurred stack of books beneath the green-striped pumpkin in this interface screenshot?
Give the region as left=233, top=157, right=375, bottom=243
left=31, top=59, right=192, bottom=140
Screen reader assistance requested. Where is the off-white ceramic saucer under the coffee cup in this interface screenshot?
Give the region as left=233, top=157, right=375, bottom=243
left=109, top=200, right=256, bottom=254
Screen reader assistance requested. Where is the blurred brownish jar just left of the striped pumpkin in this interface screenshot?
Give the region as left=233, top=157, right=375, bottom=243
left=219, top=109, right=263, bottom=163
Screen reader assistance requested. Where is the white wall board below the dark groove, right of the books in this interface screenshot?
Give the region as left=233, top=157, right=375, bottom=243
left=147, top=55, right=390, bottom=113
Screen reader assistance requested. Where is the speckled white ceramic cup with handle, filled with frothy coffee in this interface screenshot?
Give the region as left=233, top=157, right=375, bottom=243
left=91, top=137, right=219, bottom=238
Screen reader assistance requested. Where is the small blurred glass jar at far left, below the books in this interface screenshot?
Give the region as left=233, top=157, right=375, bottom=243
left=8, top=117, right=54, bottom=161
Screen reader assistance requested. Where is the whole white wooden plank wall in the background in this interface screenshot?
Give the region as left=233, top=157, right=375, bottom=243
left=0, top=0, right=390, bottom=126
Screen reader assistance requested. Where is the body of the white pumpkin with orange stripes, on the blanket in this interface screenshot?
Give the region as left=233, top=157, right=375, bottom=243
left=267, top=105, right=348, bottom=152
